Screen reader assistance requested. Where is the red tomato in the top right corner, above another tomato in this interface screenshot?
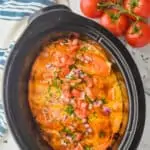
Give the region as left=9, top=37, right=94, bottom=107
left=124, top=0, right=150, bottom=18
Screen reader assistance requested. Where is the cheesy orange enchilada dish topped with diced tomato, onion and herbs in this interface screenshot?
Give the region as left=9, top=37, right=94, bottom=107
left=29, top=37, right=128, bottom=150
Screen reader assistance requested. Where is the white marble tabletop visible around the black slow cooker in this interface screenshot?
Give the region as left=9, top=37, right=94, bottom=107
left=0, top=0, right=150, bottom=150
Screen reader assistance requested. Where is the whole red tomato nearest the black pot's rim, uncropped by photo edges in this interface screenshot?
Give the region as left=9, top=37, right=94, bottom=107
left=100, top=9, right=128, bottom=36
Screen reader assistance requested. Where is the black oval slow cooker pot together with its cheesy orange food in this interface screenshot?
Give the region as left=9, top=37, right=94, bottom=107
left=3, top=5, right=145, bottom=150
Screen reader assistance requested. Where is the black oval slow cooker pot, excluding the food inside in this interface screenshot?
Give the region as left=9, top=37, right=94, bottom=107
left=3, top=5, right=145, bottom=150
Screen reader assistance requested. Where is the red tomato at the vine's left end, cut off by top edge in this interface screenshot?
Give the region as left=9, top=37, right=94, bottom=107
left=80, top=0, right=102, bottom=18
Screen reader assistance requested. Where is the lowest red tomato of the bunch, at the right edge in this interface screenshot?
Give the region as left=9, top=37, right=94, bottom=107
left=125, top=22, right=150, bottom=47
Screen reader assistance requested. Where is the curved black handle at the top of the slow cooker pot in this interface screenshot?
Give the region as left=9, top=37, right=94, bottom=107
left=28, top=2, right=71, bottom=24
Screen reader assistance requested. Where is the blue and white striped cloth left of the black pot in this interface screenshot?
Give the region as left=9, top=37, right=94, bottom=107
left=0, top=0, right=55, bottom=140
